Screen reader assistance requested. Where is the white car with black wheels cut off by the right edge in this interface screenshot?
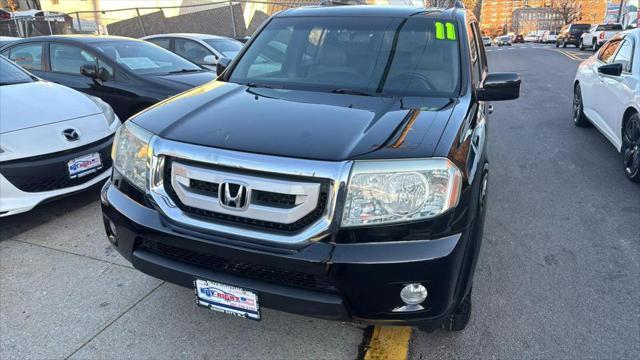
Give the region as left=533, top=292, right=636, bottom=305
left=573, top=29, right=640, bottom=182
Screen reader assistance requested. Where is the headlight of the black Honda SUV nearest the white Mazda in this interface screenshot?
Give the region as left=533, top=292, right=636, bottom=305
left=111, top=121, right=152, bottom=191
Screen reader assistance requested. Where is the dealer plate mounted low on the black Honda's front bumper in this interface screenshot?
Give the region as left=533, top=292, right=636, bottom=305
left=194, top=279, right=260, bottom=320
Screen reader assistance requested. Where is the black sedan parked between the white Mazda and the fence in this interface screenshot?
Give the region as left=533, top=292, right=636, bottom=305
left=0, top=35, right=216, bottom=121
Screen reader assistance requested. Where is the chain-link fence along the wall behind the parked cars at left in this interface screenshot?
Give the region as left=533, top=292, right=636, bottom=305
left=0, top=0, right=321, bottom=38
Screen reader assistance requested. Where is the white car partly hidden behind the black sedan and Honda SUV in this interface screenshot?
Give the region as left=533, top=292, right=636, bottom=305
left=142, top=33, right=243, bottom=70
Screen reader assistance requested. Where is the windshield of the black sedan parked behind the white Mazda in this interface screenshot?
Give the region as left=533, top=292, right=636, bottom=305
left=96, top=41, right=202, bottom=75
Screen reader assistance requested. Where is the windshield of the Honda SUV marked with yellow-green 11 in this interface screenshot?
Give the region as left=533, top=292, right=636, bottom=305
left=229, top=17, right=460, bottom=97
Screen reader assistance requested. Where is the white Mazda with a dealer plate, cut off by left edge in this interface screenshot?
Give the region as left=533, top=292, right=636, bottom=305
left=0, top=56, right=120, bottom=217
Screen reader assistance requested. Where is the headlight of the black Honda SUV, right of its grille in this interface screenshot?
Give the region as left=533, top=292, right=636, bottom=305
left=342, top=158, right=462, bottom=227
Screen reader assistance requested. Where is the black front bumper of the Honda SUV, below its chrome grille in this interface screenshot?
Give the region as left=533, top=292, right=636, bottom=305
left=101, top=182, right=474, bottom=327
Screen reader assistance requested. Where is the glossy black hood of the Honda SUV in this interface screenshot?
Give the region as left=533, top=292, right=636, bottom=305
left=133, top=81, right=453, bottom=161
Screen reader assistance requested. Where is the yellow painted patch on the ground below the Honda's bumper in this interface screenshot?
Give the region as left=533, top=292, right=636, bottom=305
left=364, top=326, right=411, bottom=360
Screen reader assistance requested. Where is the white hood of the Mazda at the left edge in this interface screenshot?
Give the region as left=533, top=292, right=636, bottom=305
left=0, top=81, right=102, bottom=134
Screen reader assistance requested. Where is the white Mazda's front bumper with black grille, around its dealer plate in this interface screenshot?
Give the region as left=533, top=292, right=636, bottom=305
left=0, top=136, right=113, bottom=217
